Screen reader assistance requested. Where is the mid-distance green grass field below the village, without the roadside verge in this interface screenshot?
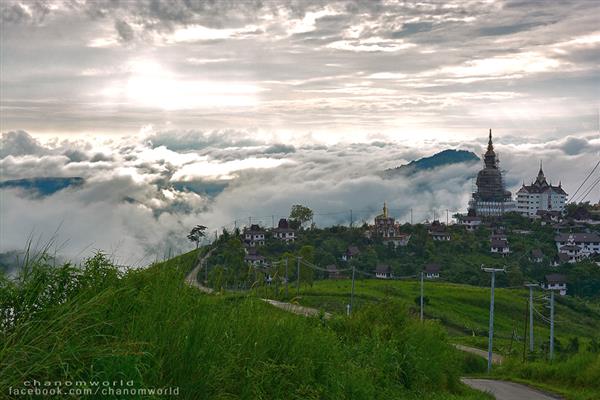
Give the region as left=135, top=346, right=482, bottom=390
left=270, top=279, right=600, bottom=354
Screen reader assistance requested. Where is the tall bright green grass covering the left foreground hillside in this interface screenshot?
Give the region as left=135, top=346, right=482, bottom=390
left=0, top=255, right=483, bottom=399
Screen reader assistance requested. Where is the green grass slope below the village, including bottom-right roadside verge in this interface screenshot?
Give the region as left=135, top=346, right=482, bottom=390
left=284, top=280, right=600, bottom=400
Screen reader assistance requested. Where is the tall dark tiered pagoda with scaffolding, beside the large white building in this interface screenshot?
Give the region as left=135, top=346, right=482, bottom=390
left=469, top=129, right=516, bottom=217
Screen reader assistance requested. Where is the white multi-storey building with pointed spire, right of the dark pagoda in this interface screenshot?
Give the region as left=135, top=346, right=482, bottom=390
left=517, top=162, right=567, bottom=217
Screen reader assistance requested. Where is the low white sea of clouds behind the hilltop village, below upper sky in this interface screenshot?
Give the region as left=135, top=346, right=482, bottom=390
left=0, top=129, right=600, bottom=266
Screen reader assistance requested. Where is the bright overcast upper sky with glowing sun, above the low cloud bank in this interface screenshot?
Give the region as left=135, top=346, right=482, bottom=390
left=0, top=0, right=600, bottom=141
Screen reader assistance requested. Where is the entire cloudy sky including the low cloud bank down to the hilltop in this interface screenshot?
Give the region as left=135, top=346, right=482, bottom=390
left=0, top=0, right=600, bottom=264
